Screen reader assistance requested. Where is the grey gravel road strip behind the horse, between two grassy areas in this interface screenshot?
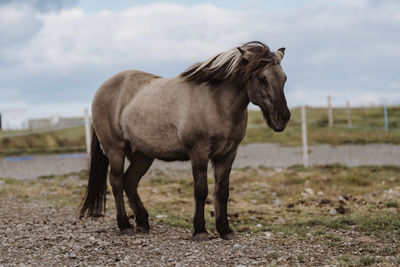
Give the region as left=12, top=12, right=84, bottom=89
left=0, top=144, right=400, bottom=179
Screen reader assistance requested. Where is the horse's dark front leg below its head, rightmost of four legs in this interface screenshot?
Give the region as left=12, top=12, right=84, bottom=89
left=213, top=149, right=236, bottom=240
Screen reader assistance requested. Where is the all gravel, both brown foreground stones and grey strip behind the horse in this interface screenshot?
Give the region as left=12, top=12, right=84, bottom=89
left=0, top=144, right=400, bottom=266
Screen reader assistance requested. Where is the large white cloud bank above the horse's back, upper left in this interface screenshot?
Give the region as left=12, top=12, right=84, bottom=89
left=11, top=3, right=249, bottom=70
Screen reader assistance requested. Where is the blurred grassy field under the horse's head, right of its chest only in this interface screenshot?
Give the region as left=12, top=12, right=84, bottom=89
left=244, top=107, right=400, bottom=146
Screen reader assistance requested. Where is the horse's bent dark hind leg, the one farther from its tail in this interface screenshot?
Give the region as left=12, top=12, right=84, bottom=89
left=124, top=152, right=154, bottom=232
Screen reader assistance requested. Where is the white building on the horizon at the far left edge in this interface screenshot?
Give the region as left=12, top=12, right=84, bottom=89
left=0, top=102, right=28, bottom=130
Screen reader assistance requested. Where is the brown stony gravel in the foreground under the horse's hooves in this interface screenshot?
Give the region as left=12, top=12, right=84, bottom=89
left=0, top=198, right=394, bottom=266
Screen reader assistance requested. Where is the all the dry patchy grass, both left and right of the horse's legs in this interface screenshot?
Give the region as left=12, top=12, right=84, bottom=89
left=0, top=165, right=400, bottom=266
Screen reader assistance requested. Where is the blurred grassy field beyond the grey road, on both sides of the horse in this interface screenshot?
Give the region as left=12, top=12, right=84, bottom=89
left=0, top=106, right=400, bottom=156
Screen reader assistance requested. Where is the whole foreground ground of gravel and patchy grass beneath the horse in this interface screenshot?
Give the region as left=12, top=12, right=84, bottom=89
left=0, top=165, right=400, bottom=266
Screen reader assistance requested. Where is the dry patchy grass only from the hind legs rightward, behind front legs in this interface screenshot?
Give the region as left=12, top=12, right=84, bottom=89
left=140, top=165, right=400, bottom=239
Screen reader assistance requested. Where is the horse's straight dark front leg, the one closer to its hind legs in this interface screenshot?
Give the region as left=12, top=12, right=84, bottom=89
left=191, top=151, right=208, bottom=241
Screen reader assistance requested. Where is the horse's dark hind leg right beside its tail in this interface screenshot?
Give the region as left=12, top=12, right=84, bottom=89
left=109, top=151, right=134, bottom=235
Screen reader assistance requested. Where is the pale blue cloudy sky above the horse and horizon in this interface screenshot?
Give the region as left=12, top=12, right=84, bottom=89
left=0, top=0, right=400, bottom=118
